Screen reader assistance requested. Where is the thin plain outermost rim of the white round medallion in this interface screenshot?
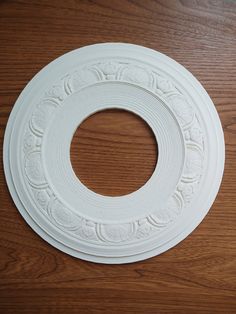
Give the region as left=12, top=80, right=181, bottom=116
left=3, top=43, right=225, bottom=264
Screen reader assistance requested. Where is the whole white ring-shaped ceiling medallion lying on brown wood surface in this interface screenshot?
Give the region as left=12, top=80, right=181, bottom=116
left=4, top=43, right=224, bottom=264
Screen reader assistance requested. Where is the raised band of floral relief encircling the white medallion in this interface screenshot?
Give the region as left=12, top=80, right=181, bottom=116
left=23, top=60, right=204, bottom=244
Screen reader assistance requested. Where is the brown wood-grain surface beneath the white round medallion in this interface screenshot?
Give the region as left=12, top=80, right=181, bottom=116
left=0, top=0, right=236, bottom=314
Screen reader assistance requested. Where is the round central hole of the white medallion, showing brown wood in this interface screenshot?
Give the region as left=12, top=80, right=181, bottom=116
left=70, top=109, right=158, bottom=196
